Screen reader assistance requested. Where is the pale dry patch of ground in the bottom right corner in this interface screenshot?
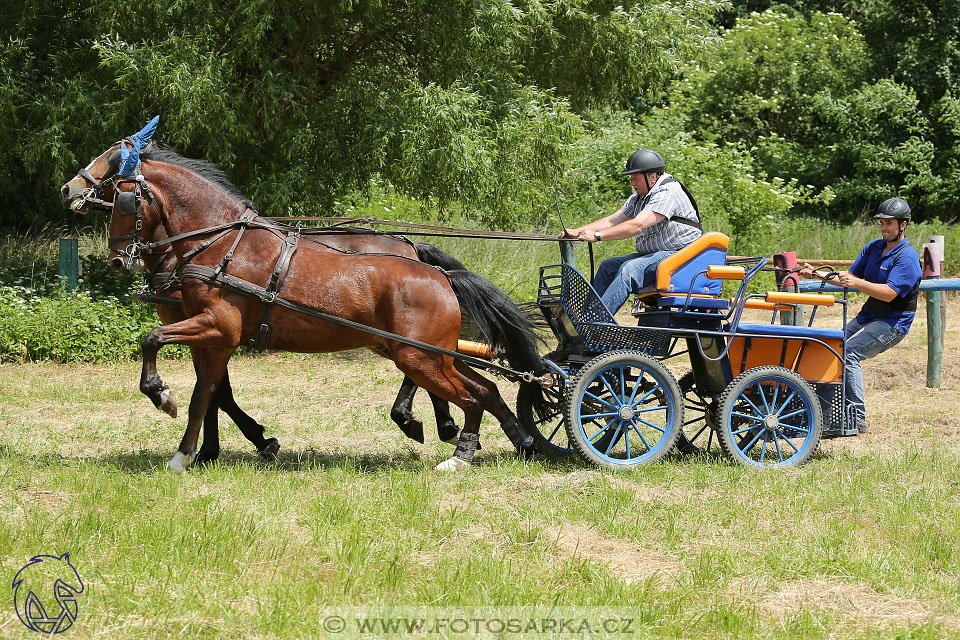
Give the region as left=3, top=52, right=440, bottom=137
left=760, top=580, right=960, bottom=631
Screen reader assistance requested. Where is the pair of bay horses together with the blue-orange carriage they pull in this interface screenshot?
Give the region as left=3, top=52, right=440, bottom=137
left=62, top=120, right=856, bottom=471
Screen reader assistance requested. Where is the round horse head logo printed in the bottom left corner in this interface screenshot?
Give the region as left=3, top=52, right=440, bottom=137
left=12, top=553, right=83, bottom=635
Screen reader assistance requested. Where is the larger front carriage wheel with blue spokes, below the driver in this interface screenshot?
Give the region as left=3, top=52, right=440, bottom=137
left=566, top=351, right=683, bottom=470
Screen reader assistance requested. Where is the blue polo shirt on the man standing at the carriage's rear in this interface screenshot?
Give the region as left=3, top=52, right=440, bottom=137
left=850, top=236, right=923, bottom=334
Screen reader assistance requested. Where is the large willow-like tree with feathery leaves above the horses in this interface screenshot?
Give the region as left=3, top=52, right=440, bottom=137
left=0, top=0, right=722, bottom=226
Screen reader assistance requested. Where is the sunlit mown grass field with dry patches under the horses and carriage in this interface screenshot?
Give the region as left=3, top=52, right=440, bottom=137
left=0, top=297, right=960, bottom=638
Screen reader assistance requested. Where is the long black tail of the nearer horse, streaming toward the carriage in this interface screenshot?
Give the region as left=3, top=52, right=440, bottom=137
left=447, top=270, right=549, bottom=422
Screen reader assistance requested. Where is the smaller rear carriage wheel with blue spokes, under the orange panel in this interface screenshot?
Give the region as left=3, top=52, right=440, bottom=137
left=718, top=366, right=823, bottom=469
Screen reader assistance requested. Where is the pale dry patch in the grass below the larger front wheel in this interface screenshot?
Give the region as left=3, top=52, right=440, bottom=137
left=543, top=524, right=685, bottom=582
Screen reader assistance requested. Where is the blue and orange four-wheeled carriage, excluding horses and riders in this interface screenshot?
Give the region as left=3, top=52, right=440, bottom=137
left=518, top=232, right=858, bottom=469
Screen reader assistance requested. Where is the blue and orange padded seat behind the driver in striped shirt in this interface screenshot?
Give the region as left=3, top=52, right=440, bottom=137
left=633, top=231, right=730, bottom=315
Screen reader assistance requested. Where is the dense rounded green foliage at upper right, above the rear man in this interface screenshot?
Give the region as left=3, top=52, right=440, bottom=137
left=673, top=2, right=957, bottom=220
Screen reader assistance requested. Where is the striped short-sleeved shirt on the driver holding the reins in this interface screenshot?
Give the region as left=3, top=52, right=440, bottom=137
left=620, top=173, right=703, bottom=255
